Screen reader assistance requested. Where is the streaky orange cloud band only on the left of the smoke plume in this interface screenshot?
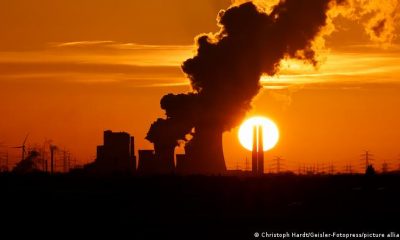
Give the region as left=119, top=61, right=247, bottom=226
left=0, top=41, right=193, bottom=87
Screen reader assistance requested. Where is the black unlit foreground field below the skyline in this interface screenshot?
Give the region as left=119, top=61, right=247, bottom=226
left=0, top=175, right=400, bottom=239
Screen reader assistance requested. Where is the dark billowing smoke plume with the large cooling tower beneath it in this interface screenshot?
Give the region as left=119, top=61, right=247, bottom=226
left=147, top=0, right=400, bottom=173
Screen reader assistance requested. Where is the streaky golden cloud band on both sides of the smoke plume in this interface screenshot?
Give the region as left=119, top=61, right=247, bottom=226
left=0, top=38, right=400, bottom=91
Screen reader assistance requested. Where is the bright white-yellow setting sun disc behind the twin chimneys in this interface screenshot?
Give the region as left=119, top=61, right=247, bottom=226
left=239, top=117, right=279, bottom=151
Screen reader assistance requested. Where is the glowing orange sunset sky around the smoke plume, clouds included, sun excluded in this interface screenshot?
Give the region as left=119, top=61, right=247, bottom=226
left=0, top=0, right=400, bottom=171
